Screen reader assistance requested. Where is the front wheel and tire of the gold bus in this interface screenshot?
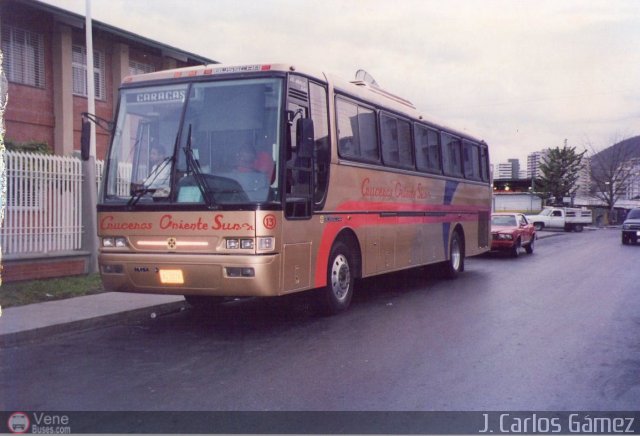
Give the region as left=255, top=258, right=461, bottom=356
left=319, top=241, right=355, bottom=315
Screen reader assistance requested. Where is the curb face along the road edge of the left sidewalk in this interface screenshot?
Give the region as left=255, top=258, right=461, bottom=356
left=0, top=301, right=186, bottom=348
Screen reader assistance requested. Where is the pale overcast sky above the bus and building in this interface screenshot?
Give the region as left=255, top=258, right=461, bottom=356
left=45, top=0, right=640, bottom=166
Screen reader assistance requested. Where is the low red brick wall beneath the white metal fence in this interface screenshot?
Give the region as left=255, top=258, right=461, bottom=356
left=2, top=258, right=86, bottom=283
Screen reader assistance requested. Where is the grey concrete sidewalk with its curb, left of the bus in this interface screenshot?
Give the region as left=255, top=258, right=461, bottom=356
left=0, top=292, right=185, bottom=347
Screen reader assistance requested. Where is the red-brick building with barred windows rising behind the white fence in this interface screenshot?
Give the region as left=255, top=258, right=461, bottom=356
left=0, top=0, right=216, bottom=159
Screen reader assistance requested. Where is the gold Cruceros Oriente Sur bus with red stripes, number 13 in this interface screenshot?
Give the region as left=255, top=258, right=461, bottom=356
left=97, top=64, right=492, bottom=314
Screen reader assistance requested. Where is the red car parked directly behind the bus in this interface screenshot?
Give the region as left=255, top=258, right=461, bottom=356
left=491, top=213, right=536, bottom=257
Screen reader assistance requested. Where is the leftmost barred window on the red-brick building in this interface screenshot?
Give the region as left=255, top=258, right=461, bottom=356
left=2, top=25, right=44, bottom=88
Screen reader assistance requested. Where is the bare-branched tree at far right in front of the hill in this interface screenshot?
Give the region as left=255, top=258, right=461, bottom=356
left=588, top=136, right=640, bottom=223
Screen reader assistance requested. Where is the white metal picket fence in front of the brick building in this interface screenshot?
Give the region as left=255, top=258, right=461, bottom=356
left=0, top=152, right=103, bottom=256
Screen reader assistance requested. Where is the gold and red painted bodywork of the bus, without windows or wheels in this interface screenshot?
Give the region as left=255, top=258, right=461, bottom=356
left=98, top=65, right=491, bottom=297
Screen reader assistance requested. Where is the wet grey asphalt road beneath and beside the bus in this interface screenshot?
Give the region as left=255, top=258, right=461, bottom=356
left=0, top=230, right=640, bottom=411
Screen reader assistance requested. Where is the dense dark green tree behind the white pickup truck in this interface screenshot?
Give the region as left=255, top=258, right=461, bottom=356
left=540, top=139, right=586, bottom=203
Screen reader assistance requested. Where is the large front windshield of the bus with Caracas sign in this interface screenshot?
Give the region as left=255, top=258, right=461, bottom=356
left=104, top=78, right=283, bottom=206
